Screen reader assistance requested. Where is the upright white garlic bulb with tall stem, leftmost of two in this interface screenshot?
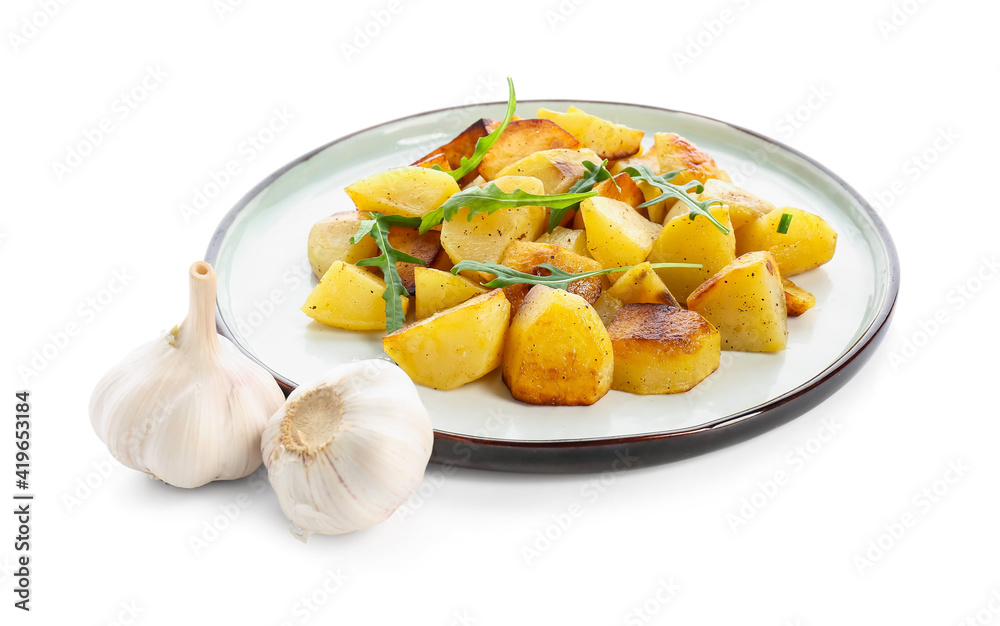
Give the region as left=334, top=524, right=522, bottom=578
left=90, top=262, right=285, bottom=487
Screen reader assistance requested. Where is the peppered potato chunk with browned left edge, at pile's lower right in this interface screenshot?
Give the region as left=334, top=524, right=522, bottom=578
left=687, top=252, right=788, bottom=352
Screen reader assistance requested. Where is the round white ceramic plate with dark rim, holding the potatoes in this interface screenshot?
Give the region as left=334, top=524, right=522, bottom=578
left=207, top=101, right=899, bottom=471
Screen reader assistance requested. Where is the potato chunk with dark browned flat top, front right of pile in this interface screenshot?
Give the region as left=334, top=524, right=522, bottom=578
left=608, top=304, right=722, bottom=395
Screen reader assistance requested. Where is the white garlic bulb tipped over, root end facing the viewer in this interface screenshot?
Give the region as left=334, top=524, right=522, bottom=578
left=262, top=359, right=434, bottom=541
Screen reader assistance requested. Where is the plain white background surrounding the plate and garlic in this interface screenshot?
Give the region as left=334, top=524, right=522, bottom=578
left=0, top=0, right=1000, bottom=625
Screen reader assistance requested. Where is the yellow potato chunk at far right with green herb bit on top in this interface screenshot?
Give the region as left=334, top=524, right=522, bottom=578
left=736, top=207, right=837, bottom=276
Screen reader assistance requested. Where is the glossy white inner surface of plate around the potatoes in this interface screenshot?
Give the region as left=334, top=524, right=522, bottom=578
left=216, top=102, right=888, bottom=441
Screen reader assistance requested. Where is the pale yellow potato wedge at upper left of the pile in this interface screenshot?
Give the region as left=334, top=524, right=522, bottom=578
left=344, top=165, right=459, bottom=217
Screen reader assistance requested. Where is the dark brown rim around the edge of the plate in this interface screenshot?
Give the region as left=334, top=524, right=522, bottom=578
left=205, top=99, right=900, bottom=473
